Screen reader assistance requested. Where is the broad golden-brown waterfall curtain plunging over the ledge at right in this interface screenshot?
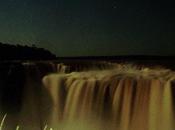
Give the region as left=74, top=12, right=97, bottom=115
left=43, top=68, right=175, bottom=130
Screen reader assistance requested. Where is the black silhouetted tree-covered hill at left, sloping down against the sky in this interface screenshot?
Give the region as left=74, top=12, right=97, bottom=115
left=0, top=42, right=56, bottom=60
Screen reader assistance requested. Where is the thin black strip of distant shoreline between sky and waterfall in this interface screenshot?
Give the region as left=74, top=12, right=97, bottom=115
left=0, top=55, right=175, bottom=70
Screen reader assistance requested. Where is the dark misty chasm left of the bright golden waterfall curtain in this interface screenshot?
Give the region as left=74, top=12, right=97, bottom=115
left=0, top=62, right=56, bottom=130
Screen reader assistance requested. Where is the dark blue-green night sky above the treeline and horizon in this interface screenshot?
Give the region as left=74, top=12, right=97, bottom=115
left=0, top=0, right=175, bottom=56
